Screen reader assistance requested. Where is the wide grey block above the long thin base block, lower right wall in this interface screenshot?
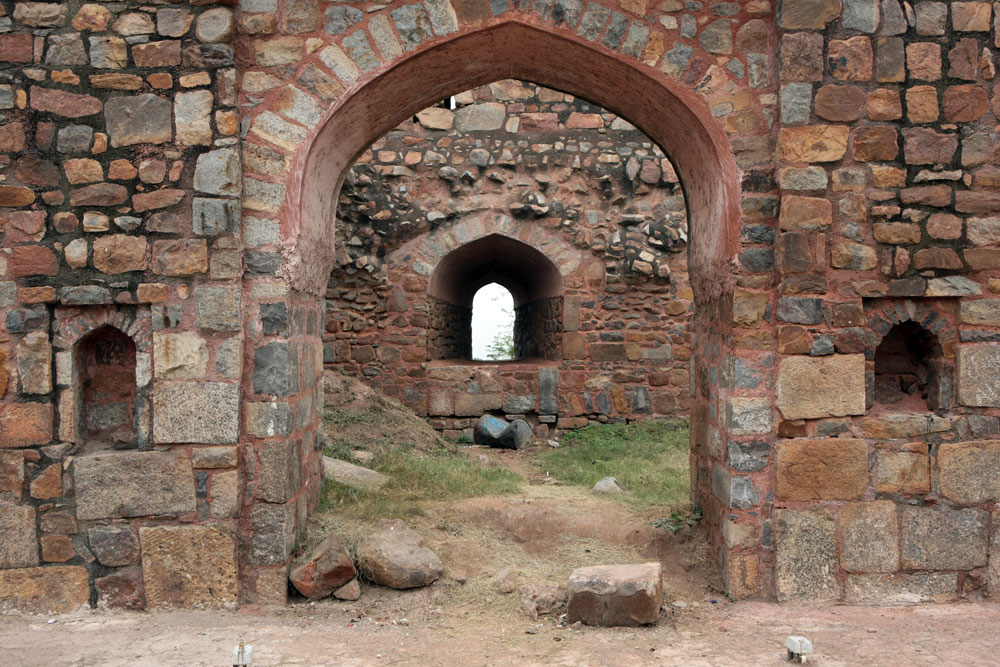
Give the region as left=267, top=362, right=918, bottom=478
left=900, top=505, right=990, bottom=570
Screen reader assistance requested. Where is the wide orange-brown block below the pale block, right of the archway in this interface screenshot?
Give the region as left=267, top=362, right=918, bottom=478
left=775, top=438, right=868, bottom=500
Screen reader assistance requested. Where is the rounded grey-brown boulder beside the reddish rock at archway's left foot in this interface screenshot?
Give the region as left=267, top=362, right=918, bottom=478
left=356, top=521, right=444, bottom=589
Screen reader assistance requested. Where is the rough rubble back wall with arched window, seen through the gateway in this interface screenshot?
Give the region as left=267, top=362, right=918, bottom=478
left=326, top=80, right=692, bottom=435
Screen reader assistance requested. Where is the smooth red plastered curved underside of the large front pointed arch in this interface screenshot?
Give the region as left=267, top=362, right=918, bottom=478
left=282, top=18, right=740, bottom=299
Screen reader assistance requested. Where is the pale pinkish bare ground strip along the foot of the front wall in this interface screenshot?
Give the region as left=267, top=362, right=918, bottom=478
left=0, top=592, right=1000, bottom=667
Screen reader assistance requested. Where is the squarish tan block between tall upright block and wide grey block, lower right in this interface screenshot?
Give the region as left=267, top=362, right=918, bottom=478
left=840, top=500, right=899, bottom=572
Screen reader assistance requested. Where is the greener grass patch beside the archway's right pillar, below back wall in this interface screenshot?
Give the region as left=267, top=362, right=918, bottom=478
left=535, top=420, right=691, bottom=507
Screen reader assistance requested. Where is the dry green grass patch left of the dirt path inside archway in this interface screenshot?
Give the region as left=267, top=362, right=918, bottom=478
left=320, top=449, right=524, bottom=519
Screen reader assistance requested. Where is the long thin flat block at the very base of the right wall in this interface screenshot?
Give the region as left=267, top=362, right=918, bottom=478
left=844, top=572, right=958, bottom=605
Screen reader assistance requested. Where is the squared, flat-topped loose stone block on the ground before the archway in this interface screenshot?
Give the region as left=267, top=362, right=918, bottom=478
left=566, top=563, right=663, bottom=627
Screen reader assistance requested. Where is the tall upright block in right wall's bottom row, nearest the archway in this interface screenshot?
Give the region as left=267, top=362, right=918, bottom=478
left=775, top=510, right=840, bottom=602
